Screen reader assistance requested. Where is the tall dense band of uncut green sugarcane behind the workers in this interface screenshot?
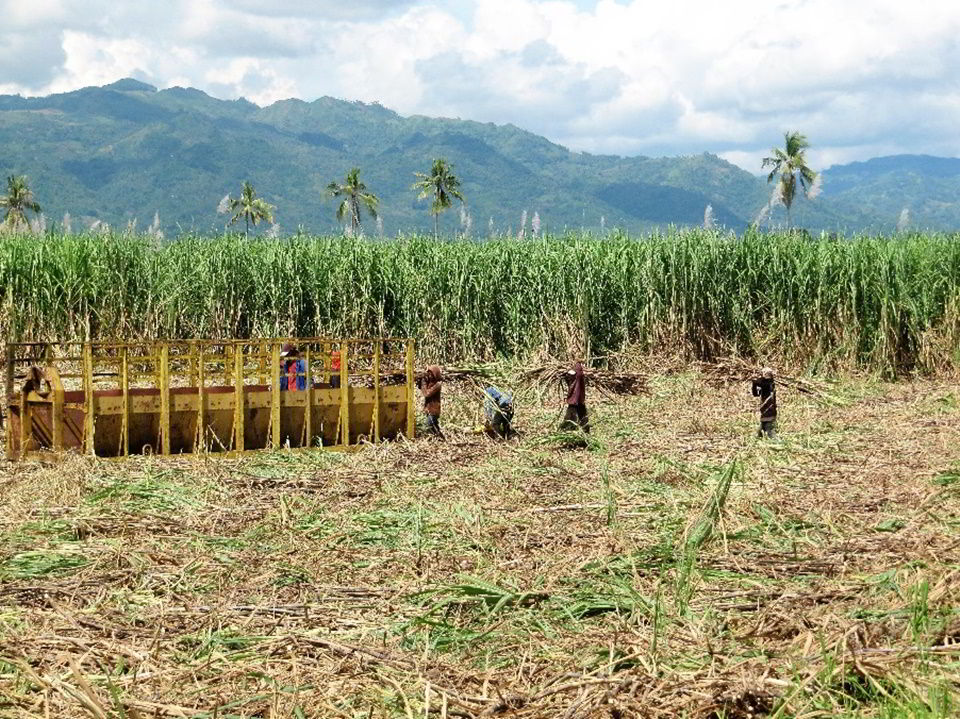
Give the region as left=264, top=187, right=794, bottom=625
left=0, top=231, right=960, bottom=375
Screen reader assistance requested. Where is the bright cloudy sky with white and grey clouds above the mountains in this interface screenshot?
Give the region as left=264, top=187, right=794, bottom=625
left=0, top=0, right=960, bottom=172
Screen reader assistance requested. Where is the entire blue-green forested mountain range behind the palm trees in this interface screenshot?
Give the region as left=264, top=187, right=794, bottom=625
left=0, top=79, right=960, bottom=236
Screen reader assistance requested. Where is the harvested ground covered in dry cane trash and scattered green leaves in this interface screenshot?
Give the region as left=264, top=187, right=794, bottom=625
left=0, top=370, right=960, bottom=719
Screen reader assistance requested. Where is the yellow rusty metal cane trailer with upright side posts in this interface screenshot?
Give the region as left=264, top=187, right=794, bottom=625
left=5, top=338, right=415, bottom=460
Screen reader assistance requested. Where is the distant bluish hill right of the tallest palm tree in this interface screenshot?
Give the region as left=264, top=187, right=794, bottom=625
left=823, top=155, right=960, bottom=229
